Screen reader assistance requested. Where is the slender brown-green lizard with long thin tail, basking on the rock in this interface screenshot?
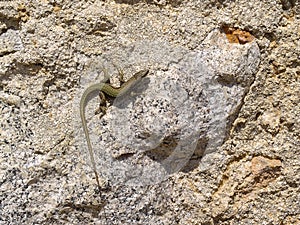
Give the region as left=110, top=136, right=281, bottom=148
left=80, top=70, right=149, bottom=189
